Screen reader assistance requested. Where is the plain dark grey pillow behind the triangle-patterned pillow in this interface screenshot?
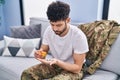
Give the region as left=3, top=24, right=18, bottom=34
left=10, top=24, right=41, bottom=39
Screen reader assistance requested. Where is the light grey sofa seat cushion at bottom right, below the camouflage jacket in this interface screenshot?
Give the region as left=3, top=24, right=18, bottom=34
left=82, top=70, right=118, bottom=80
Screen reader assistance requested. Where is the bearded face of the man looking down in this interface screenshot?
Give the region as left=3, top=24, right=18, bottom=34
left=50, top=20, right=67, bottom=35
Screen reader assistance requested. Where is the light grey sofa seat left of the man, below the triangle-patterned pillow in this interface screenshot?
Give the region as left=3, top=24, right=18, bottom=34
left=0, top=55, right=52, bottom=80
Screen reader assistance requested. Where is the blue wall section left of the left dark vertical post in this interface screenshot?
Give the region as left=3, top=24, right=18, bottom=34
left=3, top=0, right=21, bottom=35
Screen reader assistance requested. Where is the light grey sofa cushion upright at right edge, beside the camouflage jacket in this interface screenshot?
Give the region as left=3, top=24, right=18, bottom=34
left=101, top=33, right=120, bottom=75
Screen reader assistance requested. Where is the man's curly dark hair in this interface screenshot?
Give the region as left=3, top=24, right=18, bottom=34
left=47, top=1, right=70, bottom=22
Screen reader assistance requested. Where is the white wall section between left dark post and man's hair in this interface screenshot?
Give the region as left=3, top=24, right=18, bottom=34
left=23, top=0, right=55, bottom=25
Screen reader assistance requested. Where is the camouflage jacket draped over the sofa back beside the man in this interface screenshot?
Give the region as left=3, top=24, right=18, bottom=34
left=78, top=20, right=120, bottom=74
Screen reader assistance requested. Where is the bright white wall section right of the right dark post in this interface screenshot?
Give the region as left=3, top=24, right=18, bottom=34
left=108, top=0, right=120, bottom=23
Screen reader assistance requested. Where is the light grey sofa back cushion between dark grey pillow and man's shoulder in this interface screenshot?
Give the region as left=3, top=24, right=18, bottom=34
left=30, top=17, right=50, bottom=37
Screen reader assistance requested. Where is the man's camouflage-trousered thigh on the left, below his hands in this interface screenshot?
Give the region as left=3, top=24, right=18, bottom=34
left=25, top=64, right=57, bottom=78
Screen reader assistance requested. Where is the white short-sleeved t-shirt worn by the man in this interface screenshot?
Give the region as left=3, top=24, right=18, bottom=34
left=42, top=25, right=89, bottom=63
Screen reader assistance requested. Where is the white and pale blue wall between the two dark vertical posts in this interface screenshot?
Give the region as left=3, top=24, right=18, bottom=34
left=23, top=0, right=103, bottom=25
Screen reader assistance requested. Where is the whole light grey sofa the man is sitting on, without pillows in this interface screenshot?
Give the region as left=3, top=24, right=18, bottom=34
left=0, top=18, right=120, bottom=80
